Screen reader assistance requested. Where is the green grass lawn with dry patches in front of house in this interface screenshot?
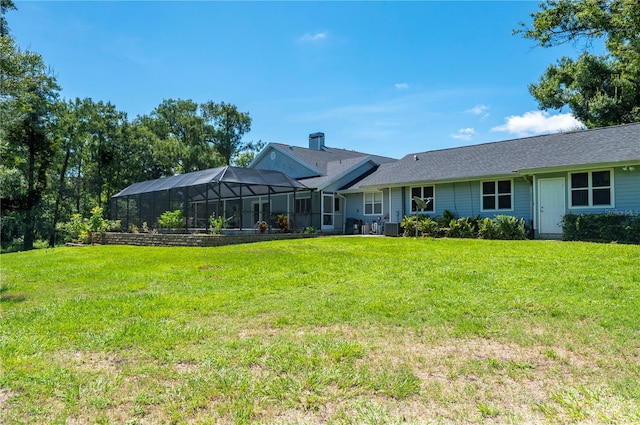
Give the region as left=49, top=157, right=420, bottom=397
left=0, top=237, right=640, bottom=424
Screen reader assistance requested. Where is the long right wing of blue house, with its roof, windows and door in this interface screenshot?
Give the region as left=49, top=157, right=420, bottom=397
left=339, top=123, right=640, bottom=238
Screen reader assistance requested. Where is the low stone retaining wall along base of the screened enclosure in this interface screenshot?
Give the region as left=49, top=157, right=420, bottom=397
left=102, top=233, right=316, bottom=246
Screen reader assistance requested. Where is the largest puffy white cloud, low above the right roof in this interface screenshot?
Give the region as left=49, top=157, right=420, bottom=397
left=491, top=111, right=584, bottom=137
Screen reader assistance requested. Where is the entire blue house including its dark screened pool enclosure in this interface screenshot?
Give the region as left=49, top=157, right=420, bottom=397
left=112, top=123, right=640, bottom=238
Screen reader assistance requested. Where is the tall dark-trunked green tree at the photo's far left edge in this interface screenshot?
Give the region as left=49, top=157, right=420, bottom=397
left=0, top=34, right=59, bottom=249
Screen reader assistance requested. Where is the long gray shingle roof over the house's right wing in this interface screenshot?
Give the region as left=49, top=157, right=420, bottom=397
left=350, top=123, right=640, bottom=189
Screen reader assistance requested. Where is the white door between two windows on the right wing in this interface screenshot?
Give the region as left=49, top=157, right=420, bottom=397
left=538, top=177, right=567, bottom=235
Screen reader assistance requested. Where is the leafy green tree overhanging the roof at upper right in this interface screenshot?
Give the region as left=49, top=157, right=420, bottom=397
left=515, top=0, right=640, bottom=128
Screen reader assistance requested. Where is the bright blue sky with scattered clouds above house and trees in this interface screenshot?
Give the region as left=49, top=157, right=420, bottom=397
left=7, top=1, right=592, bottom=158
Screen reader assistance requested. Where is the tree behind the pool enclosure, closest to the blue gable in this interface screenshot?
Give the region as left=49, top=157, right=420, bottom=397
left=200, top=101, right=251, bottom=165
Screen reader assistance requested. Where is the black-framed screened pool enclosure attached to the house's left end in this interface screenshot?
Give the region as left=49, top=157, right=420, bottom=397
left=111, top=166, right=312, bottom=230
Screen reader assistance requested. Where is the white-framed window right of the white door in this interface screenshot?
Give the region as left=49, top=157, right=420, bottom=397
left=571, top=170, right=611, bottom=207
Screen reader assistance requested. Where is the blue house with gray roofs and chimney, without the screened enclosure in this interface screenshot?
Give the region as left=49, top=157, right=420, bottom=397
left=250, top=123, right=640, bottom=238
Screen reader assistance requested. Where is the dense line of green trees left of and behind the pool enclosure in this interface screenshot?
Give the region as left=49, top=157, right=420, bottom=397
left=0, top=0, right=263, bottom=249
